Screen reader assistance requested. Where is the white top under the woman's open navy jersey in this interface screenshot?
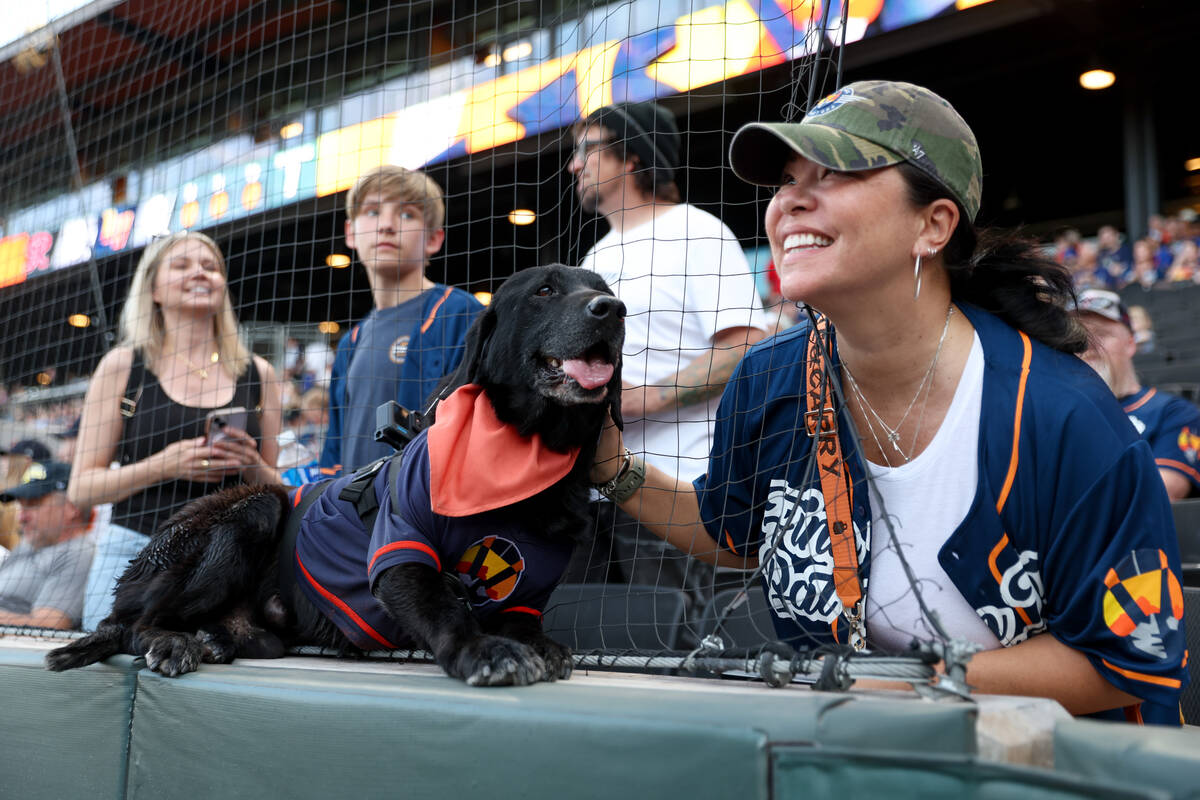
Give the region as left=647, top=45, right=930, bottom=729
left=859, top=333, right=1000, bottom=651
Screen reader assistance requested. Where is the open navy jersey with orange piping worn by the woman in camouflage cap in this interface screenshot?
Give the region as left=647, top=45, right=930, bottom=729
left=695, top=303, right=1188, bottom=724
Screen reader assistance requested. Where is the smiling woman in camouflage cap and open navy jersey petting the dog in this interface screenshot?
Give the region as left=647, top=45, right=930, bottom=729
left=592, top=80, right=1187, bottom=724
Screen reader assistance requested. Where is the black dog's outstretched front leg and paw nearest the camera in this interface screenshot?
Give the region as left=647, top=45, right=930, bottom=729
left=374, top=564, right=546, bottom=686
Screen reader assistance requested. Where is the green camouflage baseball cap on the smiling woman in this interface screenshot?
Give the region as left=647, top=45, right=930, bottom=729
left=730, top=80, right=983, bottom=219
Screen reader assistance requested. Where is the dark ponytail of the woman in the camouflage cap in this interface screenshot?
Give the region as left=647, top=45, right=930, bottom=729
left=896, top=162, right=1087, bottom=353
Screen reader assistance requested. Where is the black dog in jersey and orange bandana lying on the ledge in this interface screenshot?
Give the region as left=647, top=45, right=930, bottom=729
left=46, top=265, right=625, bottom=685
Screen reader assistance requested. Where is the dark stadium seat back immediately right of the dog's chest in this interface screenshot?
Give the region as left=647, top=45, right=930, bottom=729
left=542, top=583, right=686, bottom=652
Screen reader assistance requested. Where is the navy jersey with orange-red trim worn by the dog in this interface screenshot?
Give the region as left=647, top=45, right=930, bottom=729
left=294, top=431, right=572, bottom=650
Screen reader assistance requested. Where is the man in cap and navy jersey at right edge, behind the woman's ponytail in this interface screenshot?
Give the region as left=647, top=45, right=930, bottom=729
left=1076, top=289, right=1200, bottom=500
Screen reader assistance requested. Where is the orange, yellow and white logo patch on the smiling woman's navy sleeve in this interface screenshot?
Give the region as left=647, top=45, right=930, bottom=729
left=1103, top=549, right=1183, bottom=658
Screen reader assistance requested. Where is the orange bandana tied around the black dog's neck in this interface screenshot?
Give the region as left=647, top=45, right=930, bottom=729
left=427, top=384, right=580, bottom=517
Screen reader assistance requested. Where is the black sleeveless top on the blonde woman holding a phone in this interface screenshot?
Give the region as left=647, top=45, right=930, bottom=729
left=113, top=350, right=263, bottom=536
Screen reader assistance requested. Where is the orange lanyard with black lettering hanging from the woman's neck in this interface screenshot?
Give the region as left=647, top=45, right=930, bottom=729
left=804, top=317, right=866, bottom=650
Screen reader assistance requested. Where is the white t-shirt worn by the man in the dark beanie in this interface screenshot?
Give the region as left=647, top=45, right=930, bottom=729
left=580, top=204, right=767, bottom=481
